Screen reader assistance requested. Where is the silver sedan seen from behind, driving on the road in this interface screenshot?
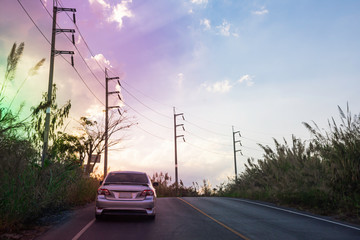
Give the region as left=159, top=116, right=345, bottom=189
left=95, top=171, right=157, bottom=219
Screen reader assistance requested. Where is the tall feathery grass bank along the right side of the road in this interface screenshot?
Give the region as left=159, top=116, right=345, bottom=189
left=218, top=107, right=360, bottom=221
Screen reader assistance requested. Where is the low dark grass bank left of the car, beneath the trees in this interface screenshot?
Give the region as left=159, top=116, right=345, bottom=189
left=0, top=133, right=99, bottom=231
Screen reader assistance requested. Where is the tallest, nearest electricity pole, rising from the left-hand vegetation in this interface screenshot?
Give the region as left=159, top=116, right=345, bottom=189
left=41, top=0, right=76, bottom=167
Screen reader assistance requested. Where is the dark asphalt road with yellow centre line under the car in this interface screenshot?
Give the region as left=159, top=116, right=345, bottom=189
left=37, top=198, right=360, bottom=240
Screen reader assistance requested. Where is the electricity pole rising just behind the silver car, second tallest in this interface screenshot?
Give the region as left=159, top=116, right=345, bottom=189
left=104, top=68, right=120, bottom=179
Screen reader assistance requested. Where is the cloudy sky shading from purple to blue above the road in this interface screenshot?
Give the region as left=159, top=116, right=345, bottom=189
left=0, top=0, right=360, bottom=187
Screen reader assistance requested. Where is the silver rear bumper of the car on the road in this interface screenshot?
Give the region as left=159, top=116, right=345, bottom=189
left=95, top=196, right=155, bottom=216
